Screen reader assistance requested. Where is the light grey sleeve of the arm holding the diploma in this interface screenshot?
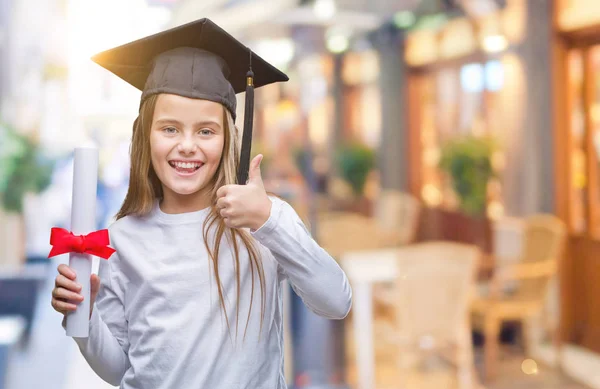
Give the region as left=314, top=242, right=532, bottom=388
left=63, top=253, right=130, bottom=386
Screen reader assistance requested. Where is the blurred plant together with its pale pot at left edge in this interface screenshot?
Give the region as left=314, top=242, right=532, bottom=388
left=0, top=123, right=54, bottom=263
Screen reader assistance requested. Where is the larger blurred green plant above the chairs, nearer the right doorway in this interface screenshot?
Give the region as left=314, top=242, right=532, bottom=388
left=440, top=135, right=496, bottom=215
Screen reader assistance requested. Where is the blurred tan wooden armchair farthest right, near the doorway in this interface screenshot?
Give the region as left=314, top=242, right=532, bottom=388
left=471, top=215, right=566, bottom=380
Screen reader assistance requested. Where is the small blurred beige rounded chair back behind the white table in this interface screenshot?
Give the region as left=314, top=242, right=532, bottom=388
left=374, top=190, right=421, bottom=245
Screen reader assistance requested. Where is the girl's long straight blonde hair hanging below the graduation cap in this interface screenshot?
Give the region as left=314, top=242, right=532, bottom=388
left=116, top=95, right=266, bottom=338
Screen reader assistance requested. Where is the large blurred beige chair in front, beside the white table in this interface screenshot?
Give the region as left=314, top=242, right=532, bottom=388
left=376, top=242, right=481, bottom=389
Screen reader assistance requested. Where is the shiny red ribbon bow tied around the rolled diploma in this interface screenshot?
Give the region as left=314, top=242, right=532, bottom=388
left=48, top=227, right=116, bottom=259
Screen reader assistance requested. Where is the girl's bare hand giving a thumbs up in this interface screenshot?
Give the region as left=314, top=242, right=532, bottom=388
left=217, top=154, right=271, bottom=230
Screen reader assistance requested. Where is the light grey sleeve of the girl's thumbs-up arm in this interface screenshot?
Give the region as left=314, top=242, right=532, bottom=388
left=250, top=196, right=352, bottom=319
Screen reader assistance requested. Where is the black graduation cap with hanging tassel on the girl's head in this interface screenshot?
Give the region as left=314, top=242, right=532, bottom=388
left=92, top=18, right=289, bottom=185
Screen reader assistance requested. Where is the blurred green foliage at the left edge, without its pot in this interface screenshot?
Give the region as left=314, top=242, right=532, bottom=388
left=0, top=123, right=54, bottom=213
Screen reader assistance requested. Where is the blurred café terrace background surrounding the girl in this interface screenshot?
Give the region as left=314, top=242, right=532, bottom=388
left=0, top=0, right=600, bottom=389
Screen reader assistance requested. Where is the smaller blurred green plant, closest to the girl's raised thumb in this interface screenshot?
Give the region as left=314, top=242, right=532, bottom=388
left=336, top=143, right=375, bottom=196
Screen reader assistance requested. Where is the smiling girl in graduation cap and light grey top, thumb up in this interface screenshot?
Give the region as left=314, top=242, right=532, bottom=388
left=52, top=19, right=351, bottom=389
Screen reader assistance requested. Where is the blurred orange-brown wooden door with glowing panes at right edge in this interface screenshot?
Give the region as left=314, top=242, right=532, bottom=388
left=555, top=31, right=600, bottom=354
